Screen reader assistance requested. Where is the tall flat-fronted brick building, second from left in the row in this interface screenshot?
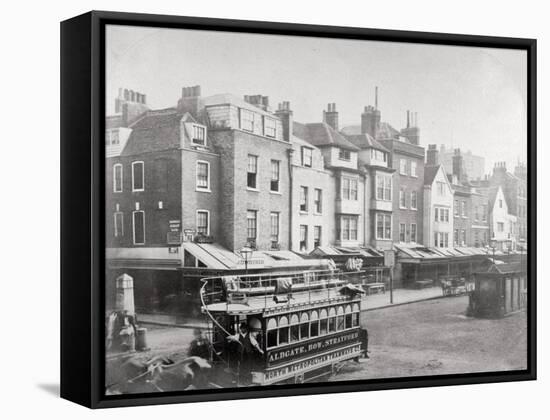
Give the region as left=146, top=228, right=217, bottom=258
left=201, top=94, right=292, bottom=250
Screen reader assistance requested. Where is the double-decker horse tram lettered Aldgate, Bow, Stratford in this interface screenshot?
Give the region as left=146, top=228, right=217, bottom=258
left=201, top=270, right=366, bottom=386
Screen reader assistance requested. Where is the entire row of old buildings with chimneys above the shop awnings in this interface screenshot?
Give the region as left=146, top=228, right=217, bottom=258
left=105, top=86, right=527, bottom=318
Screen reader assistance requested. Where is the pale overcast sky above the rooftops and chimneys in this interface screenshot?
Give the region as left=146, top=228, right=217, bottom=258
left=106, top=26, right=527, bottom=171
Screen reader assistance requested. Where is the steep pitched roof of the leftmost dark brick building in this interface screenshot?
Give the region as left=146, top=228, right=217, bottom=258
left=121, top=108, right=182, bottom=156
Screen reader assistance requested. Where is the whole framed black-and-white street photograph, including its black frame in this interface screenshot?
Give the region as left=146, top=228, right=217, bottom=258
left=61, top=12, right=536, bottom=408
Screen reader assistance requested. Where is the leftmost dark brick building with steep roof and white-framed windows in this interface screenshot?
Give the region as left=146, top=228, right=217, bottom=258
left=106, top=85, right=220, bottom=248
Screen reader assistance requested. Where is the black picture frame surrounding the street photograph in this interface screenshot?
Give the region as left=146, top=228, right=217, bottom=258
left=61, top=11, right=537, bottom=408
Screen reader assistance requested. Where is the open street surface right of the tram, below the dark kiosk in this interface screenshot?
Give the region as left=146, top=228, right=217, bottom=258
left=331, top=296, right=527, bottom=381
